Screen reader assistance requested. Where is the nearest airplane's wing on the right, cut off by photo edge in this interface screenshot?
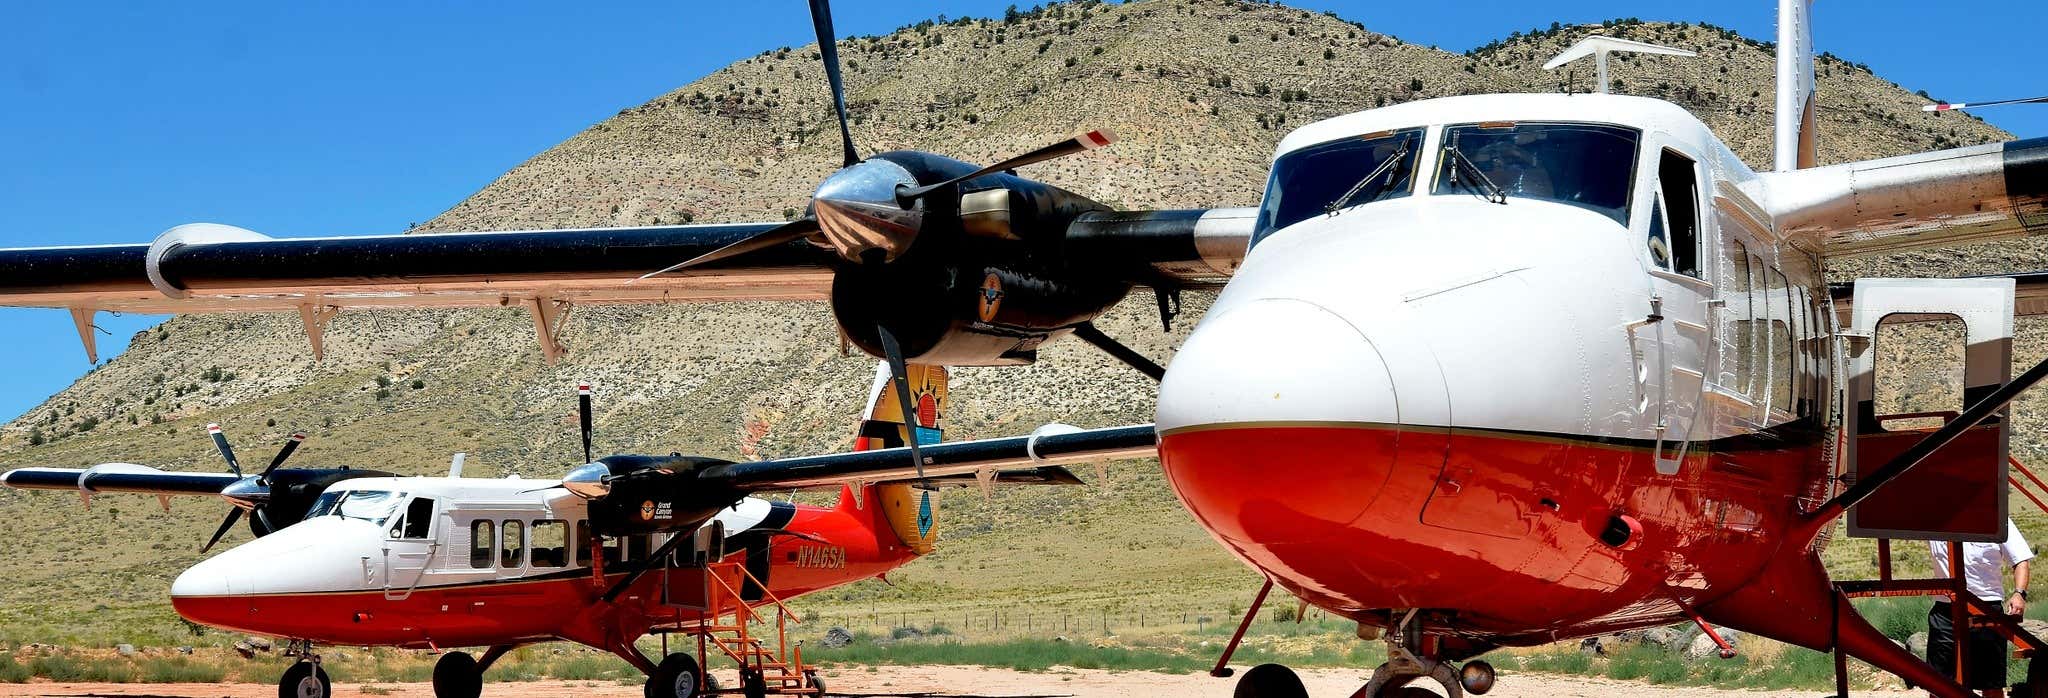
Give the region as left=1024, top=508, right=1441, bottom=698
left=1761, top=137, right=2048, bottom=258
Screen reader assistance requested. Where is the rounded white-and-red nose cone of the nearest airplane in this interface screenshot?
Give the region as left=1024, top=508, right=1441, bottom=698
left=1157, top=299, right=1401, bottom=542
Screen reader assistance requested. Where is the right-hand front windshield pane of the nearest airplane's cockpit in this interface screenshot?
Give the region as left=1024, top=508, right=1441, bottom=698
left=1430, top=123, right=1640, bottom=225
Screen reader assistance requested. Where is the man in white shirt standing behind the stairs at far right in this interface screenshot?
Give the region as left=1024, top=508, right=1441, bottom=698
left=1927, top=518, right=2034, bottom=698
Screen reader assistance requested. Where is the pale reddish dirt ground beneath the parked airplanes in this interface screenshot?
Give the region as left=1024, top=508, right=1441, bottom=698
left=0, top=667, right=1909, bottom=698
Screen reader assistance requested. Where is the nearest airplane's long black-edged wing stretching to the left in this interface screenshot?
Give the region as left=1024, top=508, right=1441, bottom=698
left=0, top=209, right=1255, bottom=362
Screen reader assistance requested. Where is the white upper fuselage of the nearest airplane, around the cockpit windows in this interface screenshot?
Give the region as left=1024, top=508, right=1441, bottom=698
left=1159, top=94, right=1819, bottom=440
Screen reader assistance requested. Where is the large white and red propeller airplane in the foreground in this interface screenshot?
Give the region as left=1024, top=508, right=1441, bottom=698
left=0, top=0, right=2048, bottom=698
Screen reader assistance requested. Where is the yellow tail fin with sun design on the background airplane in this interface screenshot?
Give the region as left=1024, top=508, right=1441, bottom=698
left=854, top=362, right=948, bottom=555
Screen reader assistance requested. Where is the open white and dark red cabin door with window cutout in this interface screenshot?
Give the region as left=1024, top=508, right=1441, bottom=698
left=1843, top=278, right=2013, bottom=542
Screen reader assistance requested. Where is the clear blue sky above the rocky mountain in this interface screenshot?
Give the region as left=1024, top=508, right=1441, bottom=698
left=0, top=0, right=2048, bottom=418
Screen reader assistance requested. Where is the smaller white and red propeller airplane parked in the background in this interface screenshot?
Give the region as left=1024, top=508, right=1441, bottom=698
left=0, top=366, right=1151, bottom=698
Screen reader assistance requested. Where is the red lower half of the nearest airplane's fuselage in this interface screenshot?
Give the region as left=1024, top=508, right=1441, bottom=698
left=1159, top=424, right=1825, bottom=641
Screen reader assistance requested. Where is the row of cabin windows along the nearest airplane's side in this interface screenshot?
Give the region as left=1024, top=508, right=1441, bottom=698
left=1718, top=242, right=1827, bottom=420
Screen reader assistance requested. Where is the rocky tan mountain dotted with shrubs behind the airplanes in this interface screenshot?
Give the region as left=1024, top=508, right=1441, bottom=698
left=0, top=0, right=2048, bottom=632
